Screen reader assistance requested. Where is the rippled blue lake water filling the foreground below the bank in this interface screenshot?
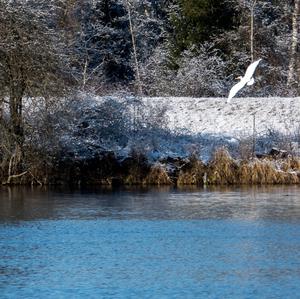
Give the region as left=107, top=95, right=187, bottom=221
left=0, top=187, right=300, bottom=299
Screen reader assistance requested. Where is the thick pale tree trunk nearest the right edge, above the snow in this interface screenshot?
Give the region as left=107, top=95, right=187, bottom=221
left=287, top=0, right=300, bottom=87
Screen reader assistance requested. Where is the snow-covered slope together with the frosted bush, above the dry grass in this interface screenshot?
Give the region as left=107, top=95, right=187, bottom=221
left=25, top=94, right=300, bottom=161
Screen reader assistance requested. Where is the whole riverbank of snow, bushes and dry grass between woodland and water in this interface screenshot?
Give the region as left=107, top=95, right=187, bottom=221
left=0, top=94, right=300, bottom=186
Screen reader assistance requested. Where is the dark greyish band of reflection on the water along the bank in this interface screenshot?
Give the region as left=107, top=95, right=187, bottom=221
left=0, top=186, right=300, bottom=221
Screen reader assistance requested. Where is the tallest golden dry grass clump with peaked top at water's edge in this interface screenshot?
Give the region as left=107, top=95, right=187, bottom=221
left=208, top=148, right=238, bottom=185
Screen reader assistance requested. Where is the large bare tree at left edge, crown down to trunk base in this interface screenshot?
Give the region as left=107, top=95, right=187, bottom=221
left=0, top=0, right=71, bottom=183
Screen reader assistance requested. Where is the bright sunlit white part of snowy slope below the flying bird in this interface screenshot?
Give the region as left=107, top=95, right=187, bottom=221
left=145, top=97, right=300, bottom=137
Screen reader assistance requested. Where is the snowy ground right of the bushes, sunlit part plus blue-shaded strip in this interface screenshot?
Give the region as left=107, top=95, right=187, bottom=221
left=144, top=97, right=300, bottom=161
